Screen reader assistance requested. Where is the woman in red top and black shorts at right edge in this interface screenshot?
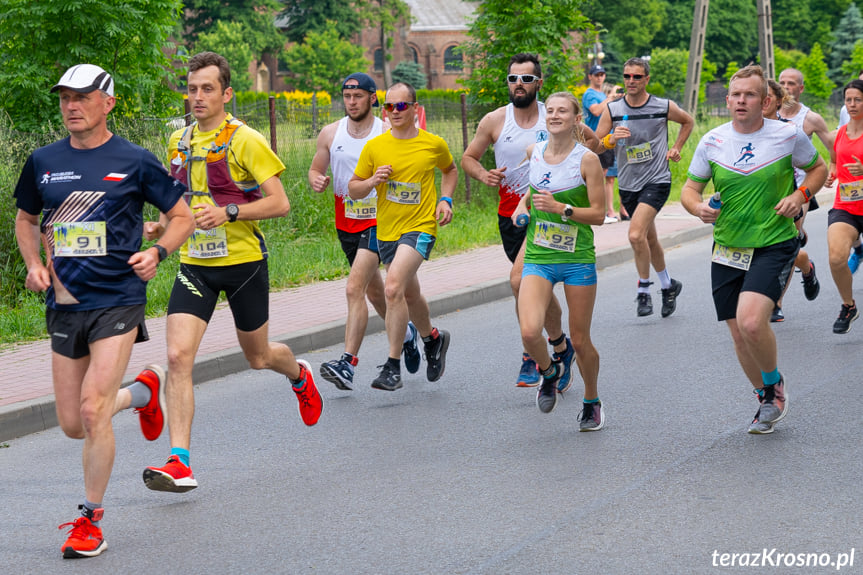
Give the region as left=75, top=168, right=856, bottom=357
left=827, top=80, right=863, bottom=333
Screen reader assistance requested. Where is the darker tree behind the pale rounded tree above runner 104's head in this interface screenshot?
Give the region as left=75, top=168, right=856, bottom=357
left=184, top=0, right=285, bottom=60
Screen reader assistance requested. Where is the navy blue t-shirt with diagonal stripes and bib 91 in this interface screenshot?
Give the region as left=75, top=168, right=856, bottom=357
left=14, top=135, right=186, bottom=311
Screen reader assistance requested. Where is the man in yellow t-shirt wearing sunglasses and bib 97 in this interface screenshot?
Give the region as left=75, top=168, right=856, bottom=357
left=348, top=82, right=458, bottom=391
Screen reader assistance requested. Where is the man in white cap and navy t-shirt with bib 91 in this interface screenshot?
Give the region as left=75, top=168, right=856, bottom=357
left=14, top=64, right=194, bottom=558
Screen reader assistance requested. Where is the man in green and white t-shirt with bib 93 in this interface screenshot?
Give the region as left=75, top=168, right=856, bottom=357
left=680, top=66, right=827, bottom=434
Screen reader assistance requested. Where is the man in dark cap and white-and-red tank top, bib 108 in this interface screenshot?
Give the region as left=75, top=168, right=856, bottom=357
left=308, top=73, right=420, bottom=390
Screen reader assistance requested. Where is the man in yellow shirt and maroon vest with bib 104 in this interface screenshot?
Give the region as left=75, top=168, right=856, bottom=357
left=138, top=52, right=323, bottom=492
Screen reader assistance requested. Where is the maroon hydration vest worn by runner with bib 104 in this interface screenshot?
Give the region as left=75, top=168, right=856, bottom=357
left=171, top=118, right=263, bottom=206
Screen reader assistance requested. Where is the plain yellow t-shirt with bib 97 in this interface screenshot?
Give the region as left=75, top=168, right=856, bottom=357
left=354, top=130, right=453, bottom=242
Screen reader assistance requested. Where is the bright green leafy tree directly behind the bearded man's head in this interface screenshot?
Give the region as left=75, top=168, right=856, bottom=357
left=460, top=0, right=596, bottom=106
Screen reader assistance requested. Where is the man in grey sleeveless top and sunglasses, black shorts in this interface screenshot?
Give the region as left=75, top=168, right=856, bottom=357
left=596, top=58, right=695, bottom=317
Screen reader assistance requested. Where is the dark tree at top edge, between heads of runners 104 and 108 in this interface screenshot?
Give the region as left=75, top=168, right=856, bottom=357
left=279, top=0, right=363, bottom=43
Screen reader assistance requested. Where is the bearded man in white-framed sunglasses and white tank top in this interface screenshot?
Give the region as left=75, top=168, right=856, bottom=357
left=461, top=53, right=576, bottom=387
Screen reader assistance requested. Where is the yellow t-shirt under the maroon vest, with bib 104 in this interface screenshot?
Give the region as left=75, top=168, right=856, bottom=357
left=168, top=114, right=285, bottom=267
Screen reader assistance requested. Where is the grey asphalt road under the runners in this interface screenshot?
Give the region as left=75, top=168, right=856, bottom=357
left=0, top=205, right=863, bottom=574
